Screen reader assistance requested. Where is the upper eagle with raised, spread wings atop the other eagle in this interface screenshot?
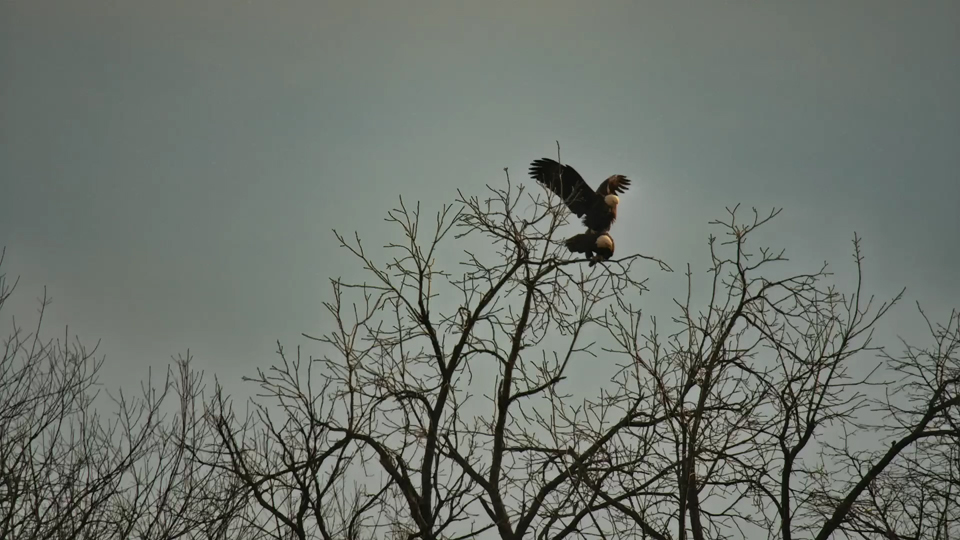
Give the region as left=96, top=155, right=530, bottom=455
left=530, top=158, right=630, bottom=233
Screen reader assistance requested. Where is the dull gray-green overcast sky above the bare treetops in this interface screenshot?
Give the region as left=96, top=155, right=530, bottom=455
left=0, top=0, right=960, bottom=400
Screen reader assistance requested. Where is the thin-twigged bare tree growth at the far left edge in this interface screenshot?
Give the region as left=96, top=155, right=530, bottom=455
left=0, top=251, right=251, bottom=540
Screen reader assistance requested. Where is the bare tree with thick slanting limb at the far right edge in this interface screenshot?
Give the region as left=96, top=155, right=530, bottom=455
left=819, top=306, right=960, bottom=539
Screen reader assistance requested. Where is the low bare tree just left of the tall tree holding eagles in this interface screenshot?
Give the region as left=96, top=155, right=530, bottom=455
left=192, top=347, right=393, bottom=540
